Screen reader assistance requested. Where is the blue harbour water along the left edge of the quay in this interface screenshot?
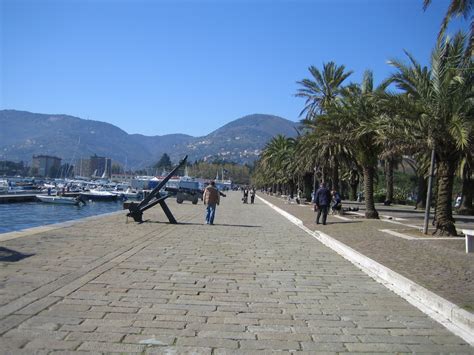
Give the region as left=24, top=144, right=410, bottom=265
left=0, top=201, right=125, bottom=233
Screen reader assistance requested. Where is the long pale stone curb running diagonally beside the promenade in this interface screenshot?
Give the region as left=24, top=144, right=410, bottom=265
left=257, top=196, right=474, bottom=346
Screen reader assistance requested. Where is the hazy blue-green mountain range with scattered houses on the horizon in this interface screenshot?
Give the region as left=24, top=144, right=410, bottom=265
left=0, top=110, right=298, bottom=168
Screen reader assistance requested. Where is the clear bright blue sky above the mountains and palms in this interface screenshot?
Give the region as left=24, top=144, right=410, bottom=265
left=0, top=0, right=468, bottom=136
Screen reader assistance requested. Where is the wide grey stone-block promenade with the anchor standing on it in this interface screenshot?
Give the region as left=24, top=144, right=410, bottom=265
left=0, top=193, right=473, bottom=354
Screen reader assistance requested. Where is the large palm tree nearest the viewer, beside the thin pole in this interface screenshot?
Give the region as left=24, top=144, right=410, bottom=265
left=390, top=33, right=473, bottom=235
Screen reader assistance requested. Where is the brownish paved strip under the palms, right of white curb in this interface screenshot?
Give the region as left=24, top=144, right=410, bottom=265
left=261, top=195, right=474, bottom=313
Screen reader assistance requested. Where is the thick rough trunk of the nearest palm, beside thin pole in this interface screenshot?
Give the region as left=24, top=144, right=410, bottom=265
left=433, top=157, right=457, bottom=236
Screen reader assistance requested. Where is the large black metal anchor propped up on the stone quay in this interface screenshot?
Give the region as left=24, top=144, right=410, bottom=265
left=127, top=155, right=188, bottom=224
